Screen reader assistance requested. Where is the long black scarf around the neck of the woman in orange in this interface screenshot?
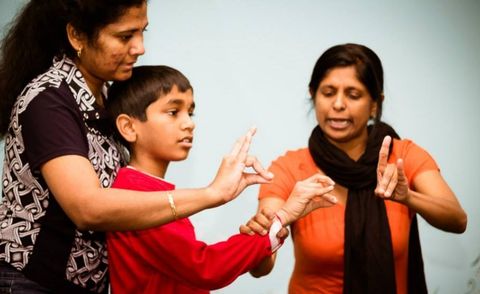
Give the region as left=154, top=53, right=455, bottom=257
left=308, top=122, right=427, bottom=294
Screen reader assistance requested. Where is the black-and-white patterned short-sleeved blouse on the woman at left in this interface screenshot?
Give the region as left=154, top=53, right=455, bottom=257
left=0, top=57, right=122, bottom=293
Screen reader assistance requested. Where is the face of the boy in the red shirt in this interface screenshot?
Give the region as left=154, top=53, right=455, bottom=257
left=131, top=86, right=195, bottom=172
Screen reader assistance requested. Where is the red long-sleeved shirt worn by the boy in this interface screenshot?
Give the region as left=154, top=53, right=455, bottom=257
left=107, top=168, right=272, bottom=294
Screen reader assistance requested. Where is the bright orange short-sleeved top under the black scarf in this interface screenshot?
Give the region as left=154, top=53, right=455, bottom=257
left=259, top=140, right=438, bottom=294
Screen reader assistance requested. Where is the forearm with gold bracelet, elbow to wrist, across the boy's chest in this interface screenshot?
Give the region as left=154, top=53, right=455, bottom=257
left=75, top=188, right=221, bottom=231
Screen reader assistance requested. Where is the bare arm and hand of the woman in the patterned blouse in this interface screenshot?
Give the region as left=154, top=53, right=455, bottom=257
left=40, top=130, right=271, bottom=231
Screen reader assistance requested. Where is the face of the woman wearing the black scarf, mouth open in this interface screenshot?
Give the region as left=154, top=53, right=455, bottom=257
left=312, top=66, right=377, bottom=146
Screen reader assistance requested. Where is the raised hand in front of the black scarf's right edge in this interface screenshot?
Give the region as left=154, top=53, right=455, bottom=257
left=375, top=136, right=409, bottom=202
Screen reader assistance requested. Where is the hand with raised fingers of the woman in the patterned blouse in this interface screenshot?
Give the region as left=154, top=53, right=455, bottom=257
left=208, top=128, right=273, bottom=203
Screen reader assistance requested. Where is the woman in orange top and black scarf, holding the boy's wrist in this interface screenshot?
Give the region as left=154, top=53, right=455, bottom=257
left=241, top=44, right=467, bottom=294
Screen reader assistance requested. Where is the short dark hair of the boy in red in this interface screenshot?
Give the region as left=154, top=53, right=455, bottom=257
left=106, top=65, right=193, bottom=148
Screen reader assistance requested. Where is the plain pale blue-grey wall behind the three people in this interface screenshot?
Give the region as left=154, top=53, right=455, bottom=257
left=0, top=0, right=480, bottom=294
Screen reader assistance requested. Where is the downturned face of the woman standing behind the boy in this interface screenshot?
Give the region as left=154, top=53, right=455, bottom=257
left=77, top=3, right=148, bottom=87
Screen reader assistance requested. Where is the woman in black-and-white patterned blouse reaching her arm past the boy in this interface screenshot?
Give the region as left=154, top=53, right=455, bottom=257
left=0, top=0, right=271, bottom=293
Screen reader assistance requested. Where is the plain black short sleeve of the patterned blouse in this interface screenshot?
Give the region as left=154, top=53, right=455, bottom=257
left=19, top=84, right=88, bottom=171
